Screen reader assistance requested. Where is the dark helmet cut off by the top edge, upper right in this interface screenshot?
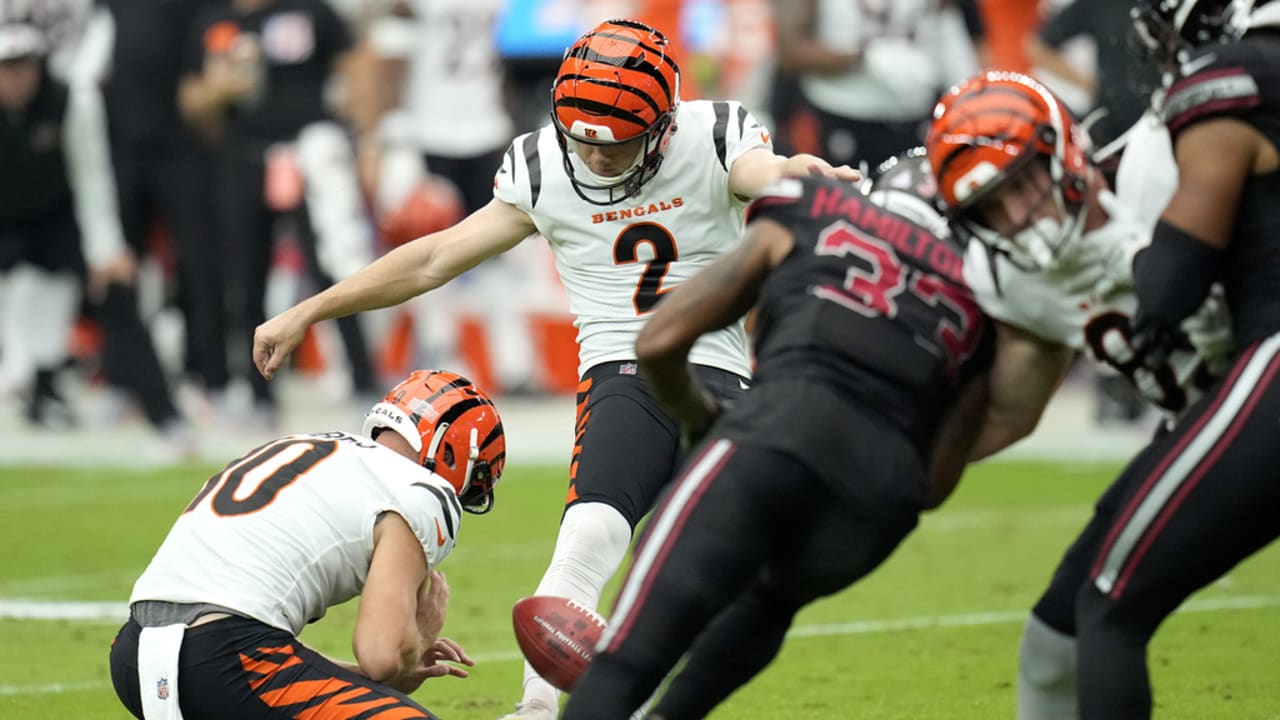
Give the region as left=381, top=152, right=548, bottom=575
left=1129, top=0, right=1253, bottom=65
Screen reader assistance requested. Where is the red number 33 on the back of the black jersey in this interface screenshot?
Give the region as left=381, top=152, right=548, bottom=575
left=813, top=220, right=983, bottom=372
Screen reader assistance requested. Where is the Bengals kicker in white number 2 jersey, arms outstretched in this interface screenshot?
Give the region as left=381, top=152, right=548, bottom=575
left=253, top=19, right=858, bottom=719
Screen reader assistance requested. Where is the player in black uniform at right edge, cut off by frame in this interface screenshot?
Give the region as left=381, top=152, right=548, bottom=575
left=1076, top=0, right=1280, bottom=719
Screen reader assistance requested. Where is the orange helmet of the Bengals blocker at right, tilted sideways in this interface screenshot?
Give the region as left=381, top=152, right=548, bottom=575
left=925, top=70, right=1092, bottom=272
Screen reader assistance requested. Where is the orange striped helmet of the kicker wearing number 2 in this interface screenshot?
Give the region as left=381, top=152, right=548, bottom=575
left=552, top=19, right=680, bottom=205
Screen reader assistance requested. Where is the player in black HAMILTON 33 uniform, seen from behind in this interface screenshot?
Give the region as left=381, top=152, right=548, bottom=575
left=564, top=154, right=1006, bottom=720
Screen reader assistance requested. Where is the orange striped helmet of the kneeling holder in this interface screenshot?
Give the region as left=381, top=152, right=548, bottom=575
left=362, top=370, right=507, bottom=515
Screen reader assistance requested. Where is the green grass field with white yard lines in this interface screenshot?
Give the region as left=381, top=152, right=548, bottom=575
left=0, top=462, right=1280, bottom=720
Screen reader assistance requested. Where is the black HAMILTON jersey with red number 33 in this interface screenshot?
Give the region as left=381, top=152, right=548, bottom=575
left=726, top=178, right=992, bottom=458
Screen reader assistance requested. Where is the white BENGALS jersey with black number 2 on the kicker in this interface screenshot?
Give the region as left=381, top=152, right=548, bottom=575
left=494, top=100, right=772, bottom=375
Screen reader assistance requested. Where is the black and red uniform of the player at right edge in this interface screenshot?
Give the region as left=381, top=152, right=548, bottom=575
left=1076, top=32, right=1280, bottom=719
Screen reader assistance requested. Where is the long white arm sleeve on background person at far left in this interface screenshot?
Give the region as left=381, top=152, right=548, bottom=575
left=63, top=82, right=124, bottom=268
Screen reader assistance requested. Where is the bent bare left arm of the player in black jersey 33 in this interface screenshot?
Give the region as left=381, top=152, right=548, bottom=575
left=636, top=219, right=794, bottom=441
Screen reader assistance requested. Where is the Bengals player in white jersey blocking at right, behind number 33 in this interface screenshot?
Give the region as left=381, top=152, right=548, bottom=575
left=927, top=58, right=1231, bottom=720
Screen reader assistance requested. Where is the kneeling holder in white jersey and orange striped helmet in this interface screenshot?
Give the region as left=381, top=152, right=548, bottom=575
left=111, top=370, right=506, bottom=720
